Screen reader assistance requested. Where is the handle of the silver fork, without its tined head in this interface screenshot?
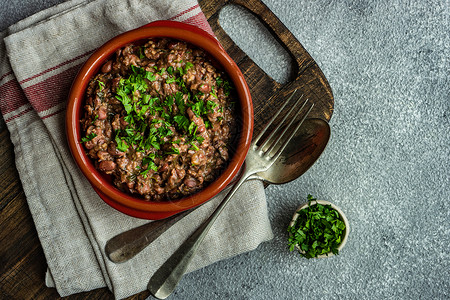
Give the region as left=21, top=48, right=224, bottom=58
left=147, top=164, right=251, bottom=299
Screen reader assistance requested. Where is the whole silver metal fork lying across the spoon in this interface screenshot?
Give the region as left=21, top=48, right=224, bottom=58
left=147, top=91, right=314, bottom=299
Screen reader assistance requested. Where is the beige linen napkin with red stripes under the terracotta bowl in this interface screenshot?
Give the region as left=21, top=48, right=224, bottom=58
left=0, top=0, right=273, bottom=298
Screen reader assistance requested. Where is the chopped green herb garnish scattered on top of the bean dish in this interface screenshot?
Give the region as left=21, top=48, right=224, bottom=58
left=103, top=48, right=234, bottom=158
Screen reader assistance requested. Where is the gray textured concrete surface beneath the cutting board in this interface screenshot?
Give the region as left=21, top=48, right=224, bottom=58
left=0, top=0, right=450, bottom=299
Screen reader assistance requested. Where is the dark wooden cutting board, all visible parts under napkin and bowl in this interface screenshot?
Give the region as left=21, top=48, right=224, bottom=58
left=0, top=0, right=334, bottom=299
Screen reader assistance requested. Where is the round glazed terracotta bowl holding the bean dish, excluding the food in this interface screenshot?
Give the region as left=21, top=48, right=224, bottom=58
left=66, top=21, right=253, bottom=220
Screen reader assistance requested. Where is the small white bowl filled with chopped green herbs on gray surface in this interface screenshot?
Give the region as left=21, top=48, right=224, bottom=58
left=288, top=195, right=350, bottom=258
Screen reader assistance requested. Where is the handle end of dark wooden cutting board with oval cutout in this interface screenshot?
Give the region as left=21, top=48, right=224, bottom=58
left=199, top=0, right=334, bottom=133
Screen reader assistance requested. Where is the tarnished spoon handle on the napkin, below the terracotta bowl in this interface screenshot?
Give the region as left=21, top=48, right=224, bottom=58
left=105, top=208, right=197, bottom=263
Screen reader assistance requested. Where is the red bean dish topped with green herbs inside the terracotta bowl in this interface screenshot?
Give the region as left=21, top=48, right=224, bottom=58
left=81, top=38, right=236, bottom=201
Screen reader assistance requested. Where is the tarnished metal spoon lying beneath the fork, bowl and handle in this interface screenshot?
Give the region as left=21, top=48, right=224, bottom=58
left=105, top=119, right=330, bottom=263
